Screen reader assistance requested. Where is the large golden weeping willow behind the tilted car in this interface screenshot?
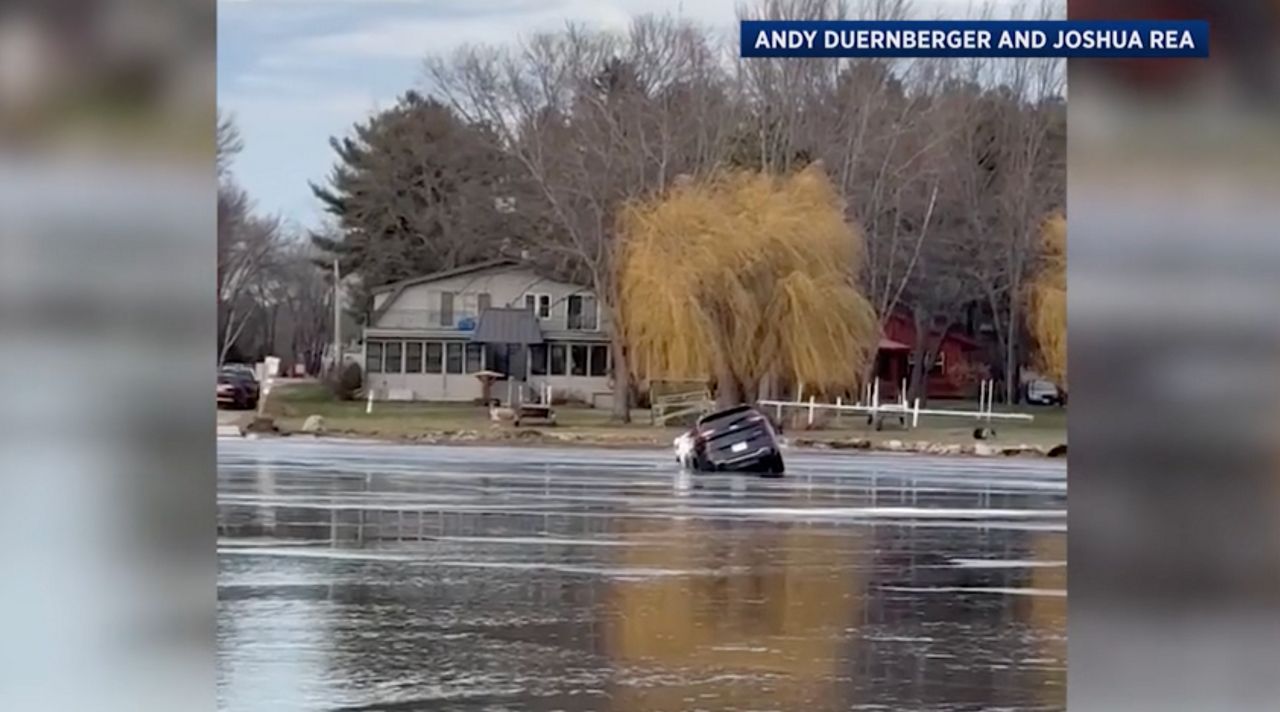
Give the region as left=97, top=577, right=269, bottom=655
left=618, top=164, right=879, bottom=405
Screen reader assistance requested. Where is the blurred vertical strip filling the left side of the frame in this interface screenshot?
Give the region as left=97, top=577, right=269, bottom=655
left=0, top=0, right=216, bottom=711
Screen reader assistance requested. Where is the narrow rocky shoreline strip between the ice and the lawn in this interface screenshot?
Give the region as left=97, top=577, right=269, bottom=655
left=219, top=419, right=1066, bottom=458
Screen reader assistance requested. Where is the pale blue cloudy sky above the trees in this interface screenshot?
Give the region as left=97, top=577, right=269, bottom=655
left=218, top=0, right=1018, bottom=229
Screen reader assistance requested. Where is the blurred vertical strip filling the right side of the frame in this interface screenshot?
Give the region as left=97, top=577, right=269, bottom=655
left=1068, top=0, right=1280, bottom=712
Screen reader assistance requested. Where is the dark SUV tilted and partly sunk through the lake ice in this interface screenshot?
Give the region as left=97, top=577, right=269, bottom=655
left=675, top=406, right=785, bottom=478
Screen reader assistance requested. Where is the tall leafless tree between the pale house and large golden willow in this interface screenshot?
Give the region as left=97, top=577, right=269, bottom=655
left=426, top=18, right=730, bottom=420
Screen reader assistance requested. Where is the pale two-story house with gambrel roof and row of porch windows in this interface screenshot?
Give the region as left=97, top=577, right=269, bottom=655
left=364, top=260, right=612, bottom=407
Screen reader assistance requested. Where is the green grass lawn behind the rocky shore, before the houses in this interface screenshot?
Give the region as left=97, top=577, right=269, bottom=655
left=252, top=383, right=1066, bottom=447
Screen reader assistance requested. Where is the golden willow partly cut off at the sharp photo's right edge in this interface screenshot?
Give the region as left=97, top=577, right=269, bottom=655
left=1027, top=215, right=1066, bottom=391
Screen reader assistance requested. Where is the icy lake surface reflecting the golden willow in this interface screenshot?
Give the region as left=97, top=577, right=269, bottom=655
left=218, top=439, right=1066, bottom=712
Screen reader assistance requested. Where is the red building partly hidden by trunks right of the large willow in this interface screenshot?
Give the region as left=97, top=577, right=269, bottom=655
left=876, top=314, right=982, bottom=401
